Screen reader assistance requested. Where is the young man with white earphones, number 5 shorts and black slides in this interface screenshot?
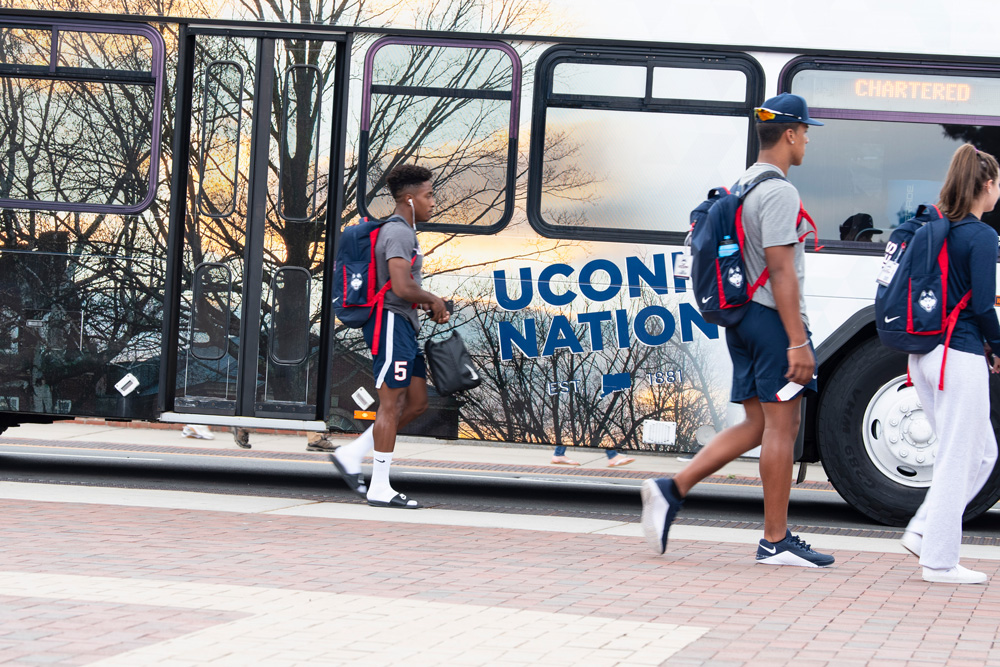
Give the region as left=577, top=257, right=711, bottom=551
left=333, top=164, right=449, bottom=509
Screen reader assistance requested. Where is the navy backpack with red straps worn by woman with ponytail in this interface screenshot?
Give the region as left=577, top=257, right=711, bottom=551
left=875, top=204, right=972, bottom=389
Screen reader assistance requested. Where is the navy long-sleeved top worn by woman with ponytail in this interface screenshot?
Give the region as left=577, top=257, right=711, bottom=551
left=948, top=214, right=1000, bottom=354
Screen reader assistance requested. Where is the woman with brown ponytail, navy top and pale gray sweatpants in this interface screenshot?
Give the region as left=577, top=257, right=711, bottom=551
left=903, top=144, right=1000, bottom=584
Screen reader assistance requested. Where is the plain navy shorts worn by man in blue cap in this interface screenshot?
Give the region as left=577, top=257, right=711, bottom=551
left=726, top=301, right=817, bottom=403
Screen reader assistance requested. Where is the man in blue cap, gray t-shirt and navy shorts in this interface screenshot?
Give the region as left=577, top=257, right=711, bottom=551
left=642, top=93, right=834, bottom=567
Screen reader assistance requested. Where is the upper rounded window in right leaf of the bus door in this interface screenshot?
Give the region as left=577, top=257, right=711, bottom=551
left=278, top=65, right=329, bottom=222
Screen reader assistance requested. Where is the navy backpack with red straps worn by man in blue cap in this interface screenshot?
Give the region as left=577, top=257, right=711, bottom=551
left=688, top=171, right=816, bottom=327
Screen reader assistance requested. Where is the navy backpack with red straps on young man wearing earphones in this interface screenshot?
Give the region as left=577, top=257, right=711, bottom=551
left=333, top=218, right=416, bottom=354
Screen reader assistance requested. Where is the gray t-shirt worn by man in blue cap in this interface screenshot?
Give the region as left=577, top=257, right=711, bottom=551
left=739, top=162, right=812, bottom=328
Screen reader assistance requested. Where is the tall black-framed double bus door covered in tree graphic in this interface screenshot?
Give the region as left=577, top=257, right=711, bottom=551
left=161, top=27, right=350, bottom=429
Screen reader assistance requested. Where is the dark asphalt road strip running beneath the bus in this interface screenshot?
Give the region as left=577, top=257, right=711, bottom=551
left=0, top=445, right=1000, bottom=538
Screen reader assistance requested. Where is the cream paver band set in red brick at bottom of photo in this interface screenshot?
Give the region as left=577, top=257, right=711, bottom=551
left=0, top=572, right=708, bottom=667
